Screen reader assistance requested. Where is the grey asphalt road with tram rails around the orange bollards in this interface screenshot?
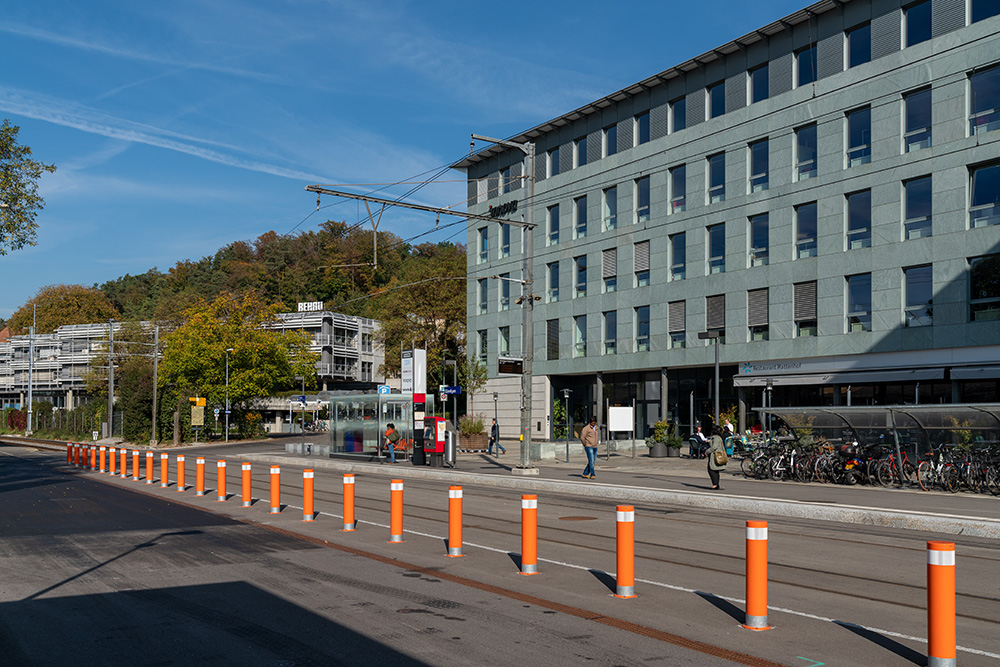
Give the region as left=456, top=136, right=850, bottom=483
left=0, top=447, right=1000, bottom=666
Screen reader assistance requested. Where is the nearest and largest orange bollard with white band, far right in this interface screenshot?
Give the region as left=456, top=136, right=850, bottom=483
left=927, top=540, right=958, bottom=667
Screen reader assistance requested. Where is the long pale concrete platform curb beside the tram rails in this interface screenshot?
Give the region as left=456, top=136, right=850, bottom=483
left=243, top=454, right=1000, bottom=539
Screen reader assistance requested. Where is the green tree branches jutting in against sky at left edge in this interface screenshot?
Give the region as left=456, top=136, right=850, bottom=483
left=0, top=118, right=56, bottom=255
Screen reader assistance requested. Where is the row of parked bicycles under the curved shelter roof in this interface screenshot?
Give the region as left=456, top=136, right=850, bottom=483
left=733, top=438, right=1000, bottom=496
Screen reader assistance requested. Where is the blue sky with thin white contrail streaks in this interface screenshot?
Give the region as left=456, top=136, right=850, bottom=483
left=0, top=0, right=805, bottom=317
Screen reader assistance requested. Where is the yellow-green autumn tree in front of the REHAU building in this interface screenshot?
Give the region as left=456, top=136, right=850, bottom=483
left=159, top=291, right=317, bottom=436
